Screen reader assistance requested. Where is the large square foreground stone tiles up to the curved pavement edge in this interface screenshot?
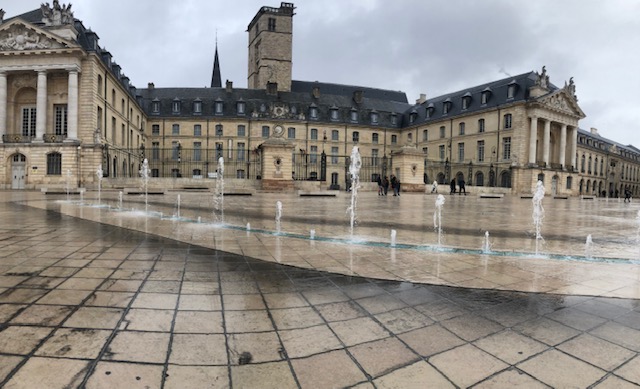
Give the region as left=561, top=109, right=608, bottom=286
left=0, top=192, right=640, bottom=388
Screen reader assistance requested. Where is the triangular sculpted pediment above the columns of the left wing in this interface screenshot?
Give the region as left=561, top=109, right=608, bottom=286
left=0, top=19, right=76, bottom=51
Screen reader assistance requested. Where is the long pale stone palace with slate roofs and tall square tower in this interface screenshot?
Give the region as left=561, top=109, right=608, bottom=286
left=0, top=0, right=640, bottom=196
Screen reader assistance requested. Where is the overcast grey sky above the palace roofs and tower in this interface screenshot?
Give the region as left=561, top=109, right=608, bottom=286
left=5, top=0, right=640, bottom=148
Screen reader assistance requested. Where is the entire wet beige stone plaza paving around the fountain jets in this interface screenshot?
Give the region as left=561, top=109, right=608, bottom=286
left=0, top=192, right=640, bottom=388
